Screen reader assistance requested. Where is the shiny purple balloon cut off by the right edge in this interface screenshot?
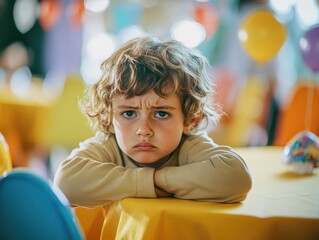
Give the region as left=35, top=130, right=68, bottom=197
left=299, top=25, right=319, bottom=72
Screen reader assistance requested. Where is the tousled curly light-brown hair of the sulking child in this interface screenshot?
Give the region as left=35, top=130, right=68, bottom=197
left=80, top=37, right=220, bottom=134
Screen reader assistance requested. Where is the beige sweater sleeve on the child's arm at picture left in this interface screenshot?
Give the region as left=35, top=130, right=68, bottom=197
left=54, top=134, right=156, bottom=207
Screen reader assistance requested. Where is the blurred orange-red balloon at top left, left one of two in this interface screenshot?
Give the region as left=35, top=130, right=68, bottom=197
left=39, top=0, right=62, bottom=31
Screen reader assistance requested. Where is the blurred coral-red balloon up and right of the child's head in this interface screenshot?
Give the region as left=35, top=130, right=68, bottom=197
left=194, top=3, right=219, bottom=38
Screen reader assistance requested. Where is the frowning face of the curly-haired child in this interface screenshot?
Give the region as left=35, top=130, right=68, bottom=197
left=111, top=91, right=190, bottom=164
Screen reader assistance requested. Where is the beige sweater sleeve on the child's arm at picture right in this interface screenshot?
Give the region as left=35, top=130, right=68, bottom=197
left=155, top=133, right=252, bottom=202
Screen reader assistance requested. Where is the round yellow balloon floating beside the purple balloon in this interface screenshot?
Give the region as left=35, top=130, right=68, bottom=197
left=238, top=10, right=286, bottom=64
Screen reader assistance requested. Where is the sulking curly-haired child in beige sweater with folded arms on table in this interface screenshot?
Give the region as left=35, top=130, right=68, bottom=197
left=54, top=37, right=251, bottom=207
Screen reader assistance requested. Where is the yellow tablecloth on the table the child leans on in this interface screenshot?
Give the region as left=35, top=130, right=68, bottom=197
left=96, top=147, right=319, bottom=240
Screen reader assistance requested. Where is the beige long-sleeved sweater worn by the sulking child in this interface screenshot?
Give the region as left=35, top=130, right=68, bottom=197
left=54, top=133, right=252, bottom=207
